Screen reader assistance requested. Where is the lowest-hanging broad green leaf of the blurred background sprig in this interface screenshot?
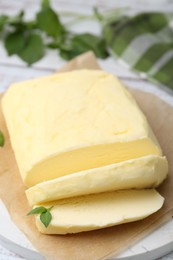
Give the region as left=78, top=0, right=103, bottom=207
left=18, top=33, right=45, bottom=65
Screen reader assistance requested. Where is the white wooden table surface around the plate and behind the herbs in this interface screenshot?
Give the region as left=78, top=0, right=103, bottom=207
left=0, top=0, right=173, bottom=260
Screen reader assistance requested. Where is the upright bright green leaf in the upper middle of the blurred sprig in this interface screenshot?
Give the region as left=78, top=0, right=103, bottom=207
left=36, top=7, right=65, bottom=37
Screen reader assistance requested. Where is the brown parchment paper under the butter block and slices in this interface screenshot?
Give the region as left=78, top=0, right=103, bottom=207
left=0, top=53, right=173, bottom=260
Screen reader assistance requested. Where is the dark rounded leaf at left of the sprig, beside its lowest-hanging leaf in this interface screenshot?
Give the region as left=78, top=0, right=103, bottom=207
left=4, top=31, right=26, bottom=55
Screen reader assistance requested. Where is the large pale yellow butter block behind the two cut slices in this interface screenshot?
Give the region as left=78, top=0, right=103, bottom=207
left=2, top=70, right=161, bottom=187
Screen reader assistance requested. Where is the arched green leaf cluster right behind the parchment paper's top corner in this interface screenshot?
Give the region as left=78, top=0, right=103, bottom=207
left=60, top=33, right=108, bottom=60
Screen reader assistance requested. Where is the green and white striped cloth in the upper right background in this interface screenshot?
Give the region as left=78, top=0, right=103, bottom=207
left=103, top=12, right=173, bottom=89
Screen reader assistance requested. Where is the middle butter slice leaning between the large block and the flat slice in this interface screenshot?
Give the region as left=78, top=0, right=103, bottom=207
left=26, top=155, right=168, bottom=205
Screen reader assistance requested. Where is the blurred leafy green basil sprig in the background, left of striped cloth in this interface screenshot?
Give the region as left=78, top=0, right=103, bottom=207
left=0, top=0, right=108, bottom=65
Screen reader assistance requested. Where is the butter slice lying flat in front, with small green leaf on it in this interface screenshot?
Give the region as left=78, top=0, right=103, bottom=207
left=36, top=189, right=164, bottom=234
